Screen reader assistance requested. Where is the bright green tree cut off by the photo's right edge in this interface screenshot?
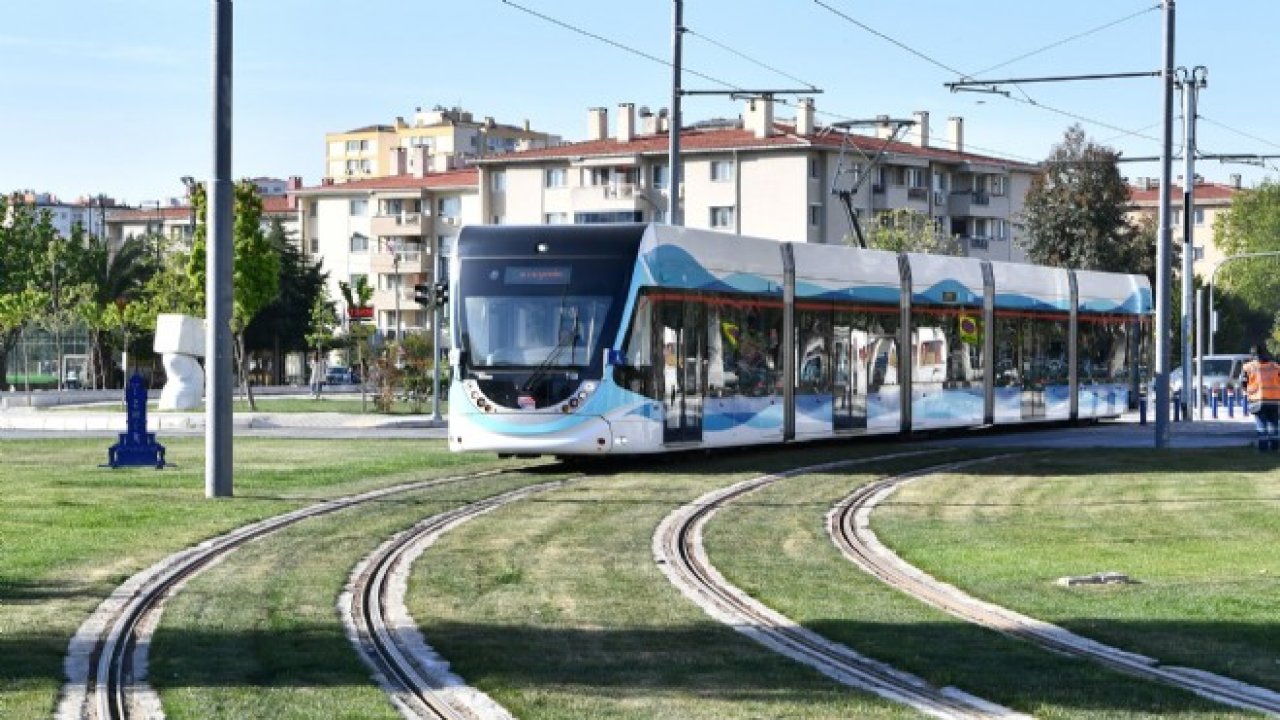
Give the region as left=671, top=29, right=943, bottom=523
left=1213, top=181, right=1280, bottom=348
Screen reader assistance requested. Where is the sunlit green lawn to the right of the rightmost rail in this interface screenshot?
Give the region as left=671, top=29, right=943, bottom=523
left=873, top=448, right=1280, bottom=691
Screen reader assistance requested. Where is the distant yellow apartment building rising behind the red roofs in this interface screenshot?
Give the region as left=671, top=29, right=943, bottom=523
left=324, top=106, right=559, bottom=182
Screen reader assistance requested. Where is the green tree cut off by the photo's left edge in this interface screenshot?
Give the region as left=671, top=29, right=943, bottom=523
left=0, top=195, right=58, bottom=384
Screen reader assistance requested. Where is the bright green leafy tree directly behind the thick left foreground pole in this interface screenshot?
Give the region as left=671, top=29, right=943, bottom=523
left=188, top=179, right=280, bottom=410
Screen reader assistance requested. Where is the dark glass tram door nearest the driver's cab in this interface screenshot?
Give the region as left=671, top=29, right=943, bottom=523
left=654, top=301, right=707, bottom=442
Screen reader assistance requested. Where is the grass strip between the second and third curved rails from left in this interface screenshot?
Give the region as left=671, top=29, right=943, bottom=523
left=410, top=448, right=916, bottom=720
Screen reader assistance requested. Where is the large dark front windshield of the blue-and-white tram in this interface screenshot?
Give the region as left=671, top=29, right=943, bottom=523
left=460, top=259, right=630, bottom=374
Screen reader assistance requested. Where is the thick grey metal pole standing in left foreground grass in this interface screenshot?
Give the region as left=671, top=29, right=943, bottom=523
left=205, top=0, right=236, bottom=497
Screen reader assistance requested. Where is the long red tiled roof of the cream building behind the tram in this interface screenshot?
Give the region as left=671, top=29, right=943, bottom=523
left=480, top=126, right=1037, bottom=172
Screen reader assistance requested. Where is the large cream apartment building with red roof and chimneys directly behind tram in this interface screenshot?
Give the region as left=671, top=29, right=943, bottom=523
left=477, top=99, right=1038, bottom=261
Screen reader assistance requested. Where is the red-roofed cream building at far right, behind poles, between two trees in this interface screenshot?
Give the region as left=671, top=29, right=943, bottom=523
left=1128, top=174, right=1242, bottom=281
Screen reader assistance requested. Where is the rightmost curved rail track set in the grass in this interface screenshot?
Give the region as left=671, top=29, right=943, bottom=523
left=827, top=455, right=1280, bottom=715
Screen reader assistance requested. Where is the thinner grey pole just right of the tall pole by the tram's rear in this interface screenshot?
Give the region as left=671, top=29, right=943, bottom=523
left=1166, top=65, right=1208, bottom=420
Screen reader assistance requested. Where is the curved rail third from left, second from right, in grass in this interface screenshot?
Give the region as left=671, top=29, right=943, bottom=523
left=653, top=451, right=1025, bottom=719
